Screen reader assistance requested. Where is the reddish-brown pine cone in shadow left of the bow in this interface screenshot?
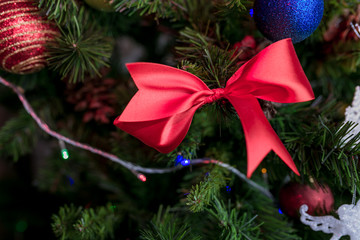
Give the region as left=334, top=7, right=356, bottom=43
left=66, top=70, right=116, bottom=124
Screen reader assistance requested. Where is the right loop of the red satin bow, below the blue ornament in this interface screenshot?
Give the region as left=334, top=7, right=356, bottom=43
left=226, top=39, right=314, bottom=103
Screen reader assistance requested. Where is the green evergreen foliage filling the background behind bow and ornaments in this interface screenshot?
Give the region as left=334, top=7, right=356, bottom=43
left=0, top=0, right=360, bottom=240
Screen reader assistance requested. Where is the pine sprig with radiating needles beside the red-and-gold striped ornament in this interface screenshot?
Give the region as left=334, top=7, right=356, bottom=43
left=48, top=8, right=112, bottom=83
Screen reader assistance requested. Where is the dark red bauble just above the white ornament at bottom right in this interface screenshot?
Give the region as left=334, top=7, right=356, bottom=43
left=279, top=182, right=334, bottom=218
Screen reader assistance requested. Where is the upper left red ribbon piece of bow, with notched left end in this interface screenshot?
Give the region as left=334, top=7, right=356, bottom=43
left=115, top=62, right=212, bottom=122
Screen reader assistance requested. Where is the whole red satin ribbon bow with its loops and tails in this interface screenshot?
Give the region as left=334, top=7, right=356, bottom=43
left=114, top=39, right=314, bottom=177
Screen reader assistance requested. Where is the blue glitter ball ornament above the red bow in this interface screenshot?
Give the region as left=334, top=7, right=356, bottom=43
left=254, top=0, right=324, bottom=43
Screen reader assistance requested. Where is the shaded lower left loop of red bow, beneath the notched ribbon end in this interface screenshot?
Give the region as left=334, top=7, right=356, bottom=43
left=114, top=106, right=198, bottom=153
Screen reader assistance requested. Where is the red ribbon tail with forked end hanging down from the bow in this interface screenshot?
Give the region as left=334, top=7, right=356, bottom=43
left=227, top=95, right=300, bottom=178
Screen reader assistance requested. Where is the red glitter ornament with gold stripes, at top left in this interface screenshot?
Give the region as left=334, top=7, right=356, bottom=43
left=0, top=0, right=59, bottom=74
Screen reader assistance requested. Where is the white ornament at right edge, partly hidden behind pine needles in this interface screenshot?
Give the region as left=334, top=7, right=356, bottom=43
left=343, top=86, right=360, bottom=144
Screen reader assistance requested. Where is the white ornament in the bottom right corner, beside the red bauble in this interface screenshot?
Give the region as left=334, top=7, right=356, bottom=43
left=300, top=200, right=360, bottom=240
